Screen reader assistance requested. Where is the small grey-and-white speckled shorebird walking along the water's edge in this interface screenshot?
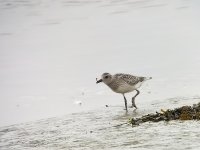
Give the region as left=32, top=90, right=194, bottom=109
left=96, top=73, right=152, bottom=111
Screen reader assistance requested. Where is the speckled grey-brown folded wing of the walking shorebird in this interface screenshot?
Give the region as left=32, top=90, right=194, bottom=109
left=115, top=73, right=145, bottom=86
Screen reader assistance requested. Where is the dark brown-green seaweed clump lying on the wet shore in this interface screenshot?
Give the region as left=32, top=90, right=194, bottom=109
left=130, top=103, right=200, bottom=126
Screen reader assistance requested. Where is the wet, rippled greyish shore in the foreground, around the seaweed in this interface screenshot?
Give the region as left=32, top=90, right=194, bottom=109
left=0, top=98, right=200, bottom=150
